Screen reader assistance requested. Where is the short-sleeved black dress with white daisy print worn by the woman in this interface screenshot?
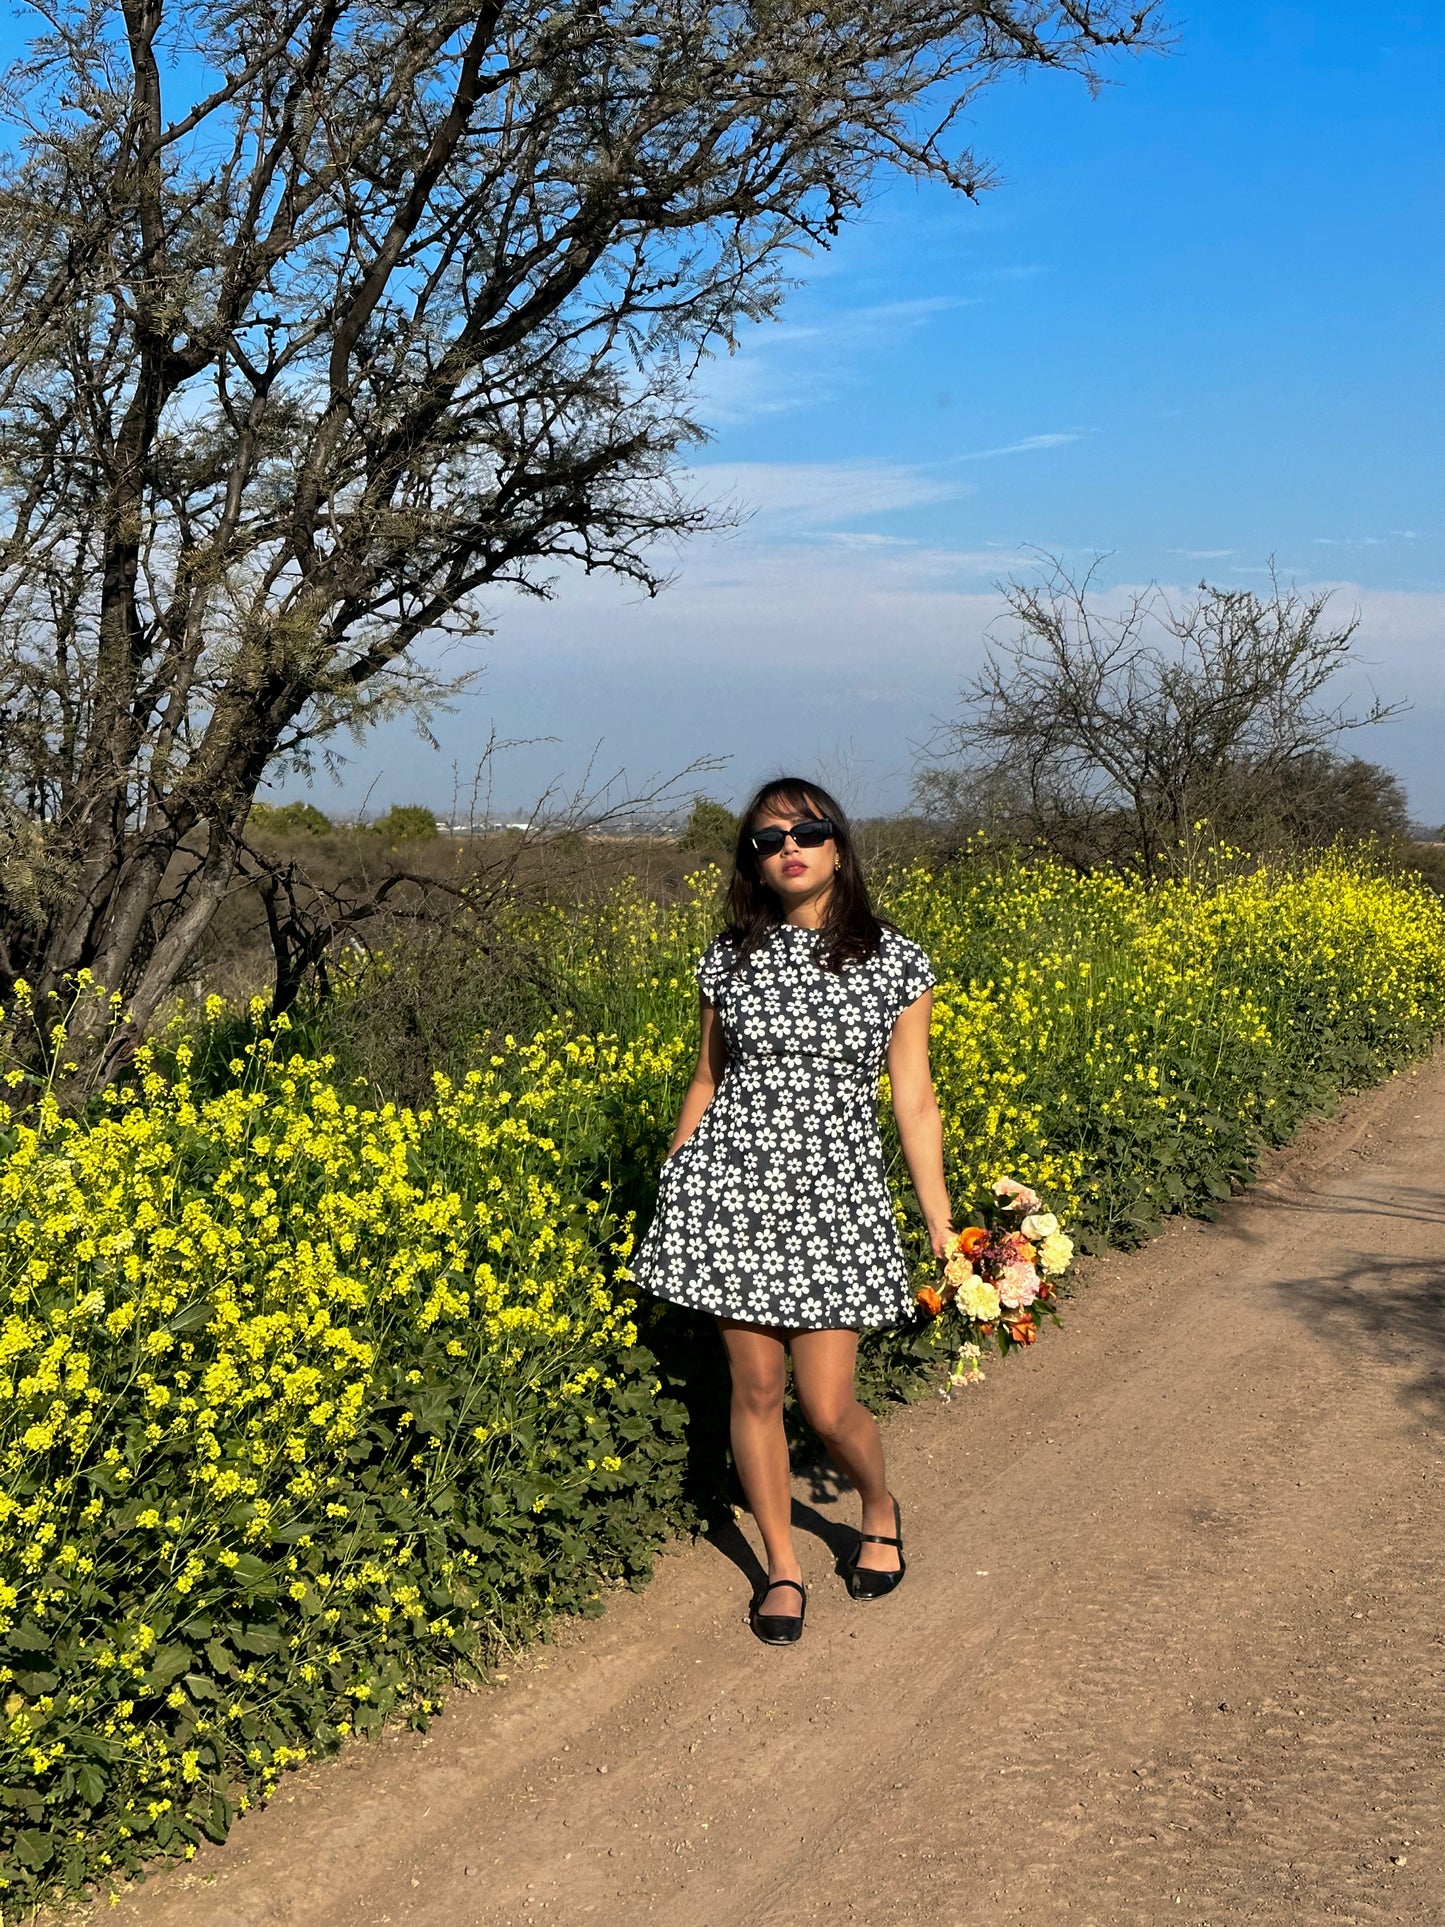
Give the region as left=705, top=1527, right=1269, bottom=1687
left=634, top=923, right=934, bottom=1332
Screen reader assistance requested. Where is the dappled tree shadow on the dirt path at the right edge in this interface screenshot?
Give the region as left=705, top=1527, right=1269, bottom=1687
left=1274, top=1240, right=1445, bottom=1418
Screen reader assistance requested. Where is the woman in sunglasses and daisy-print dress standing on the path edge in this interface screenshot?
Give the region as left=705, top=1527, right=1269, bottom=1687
left=636, top=777, right=950, bottom=1646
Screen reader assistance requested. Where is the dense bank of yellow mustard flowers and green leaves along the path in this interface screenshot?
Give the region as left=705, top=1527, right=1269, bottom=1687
left=0, top=856, right=1445, bottom=1910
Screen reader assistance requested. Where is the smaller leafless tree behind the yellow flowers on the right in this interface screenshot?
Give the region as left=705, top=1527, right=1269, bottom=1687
left=917, top=559, right=1401, bottom=879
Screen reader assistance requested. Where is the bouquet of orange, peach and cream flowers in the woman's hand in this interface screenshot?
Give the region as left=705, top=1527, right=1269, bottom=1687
left=917, top=1177, right=1073, bottom=1356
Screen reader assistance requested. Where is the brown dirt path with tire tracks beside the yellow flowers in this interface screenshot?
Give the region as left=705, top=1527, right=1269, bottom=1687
left=110, top=1058, right=1445, bottom=1927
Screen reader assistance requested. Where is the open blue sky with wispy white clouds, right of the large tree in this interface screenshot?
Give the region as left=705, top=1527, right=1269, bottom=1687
left=350, top=0, right=1445, bottom=823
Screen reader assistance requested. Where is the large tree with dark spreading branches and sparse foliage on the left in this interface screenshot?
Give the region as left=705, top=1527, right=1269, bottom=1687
left=0, top=0, right=1156, bottom=1073
